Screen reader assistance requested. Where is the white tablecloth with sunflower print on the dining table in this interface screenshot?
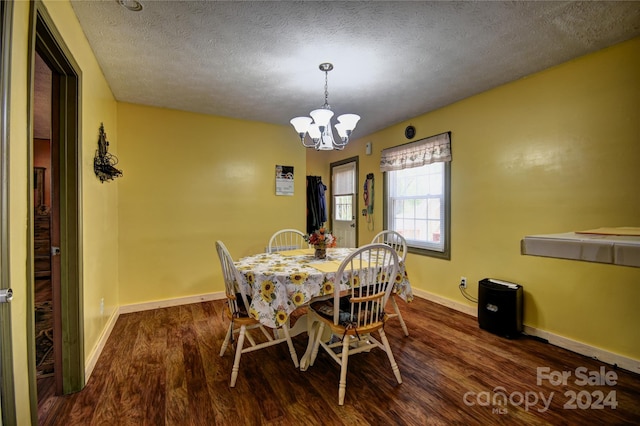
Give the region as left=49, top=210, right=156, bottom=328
left=234, top=248, right=413, bottom=327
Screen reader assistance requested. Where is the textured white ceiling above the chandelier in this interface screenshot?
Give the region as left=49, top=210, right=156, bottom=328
left=71, top=0, right=640, bottom=137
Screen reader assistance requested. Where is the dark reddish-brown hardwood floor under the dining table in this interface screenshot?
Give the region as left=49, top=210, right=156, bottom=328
left=40, top=298, right=640, bottom=425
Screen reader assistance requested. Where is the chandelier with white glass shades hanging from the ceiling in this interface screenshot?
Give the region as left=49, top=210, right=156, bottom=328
left=290, top=63, right=360, bottom=150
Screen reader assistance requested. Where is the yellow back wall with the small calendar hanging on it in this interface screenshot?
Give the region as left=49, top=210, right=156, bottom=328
left=118, top=103, right=306, bottom=305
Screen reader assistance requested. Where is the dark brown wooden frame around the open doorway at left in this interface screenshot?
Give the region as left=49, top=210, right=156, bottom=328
left=27, top=0, right=85, bottom=414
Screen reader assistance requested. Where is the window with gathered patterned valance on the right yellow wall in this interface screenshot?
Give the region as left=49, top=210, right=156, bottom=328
left=381, top=133, right=451, bottom=259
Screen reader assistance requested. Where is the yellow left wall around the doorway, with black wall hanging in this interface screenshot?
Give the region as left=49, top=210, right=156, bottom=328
left=9, top=1, right=118, bottom=425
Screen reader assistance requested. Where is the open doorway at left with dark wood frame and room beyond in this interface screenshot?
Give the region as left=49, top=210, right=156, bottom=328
left=28, top=1, right=85, bottom=418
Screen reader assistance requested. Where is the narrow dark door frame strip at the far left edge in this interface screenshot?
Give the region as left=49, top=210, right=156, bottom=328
left=0, top=1, right=17, bottom=425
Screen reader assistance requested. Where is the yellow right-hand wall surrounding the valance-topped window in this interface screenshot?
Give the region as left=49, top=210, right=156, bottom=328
left=307, top=38, right=640, bottom=360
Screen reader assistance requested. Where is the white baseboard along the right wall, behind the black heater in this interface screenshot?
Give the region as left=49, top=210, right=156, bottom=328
left=413, top=289, right=640, bottom=374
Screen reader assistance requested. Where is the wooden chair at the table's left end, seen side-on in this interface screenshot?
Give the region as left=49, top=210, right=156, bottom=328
left=216, top=241, right=299, bottom=387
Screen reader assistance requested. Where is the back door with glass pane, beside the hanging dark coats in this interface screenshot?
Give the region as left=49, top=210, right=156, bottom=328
left=331, top=157, right=358, bottom=247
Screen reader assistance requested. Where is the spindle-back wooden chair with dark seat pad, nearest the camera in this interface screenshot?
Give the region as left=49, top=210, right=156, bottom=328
left=309, top=244, right=402, bottom=405
